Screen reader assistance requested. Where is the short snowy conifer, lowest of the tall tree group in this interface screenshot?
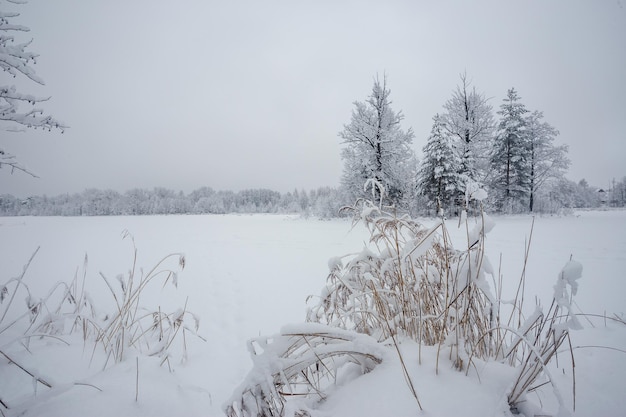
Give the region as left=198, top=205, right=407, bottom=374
left=417, top=114, right=463, bottom=213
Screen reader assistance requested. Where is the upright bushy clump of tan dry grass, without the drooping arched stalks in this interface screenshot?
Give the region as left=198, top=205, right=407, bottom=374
left=307, top=197, right=495, bottom=367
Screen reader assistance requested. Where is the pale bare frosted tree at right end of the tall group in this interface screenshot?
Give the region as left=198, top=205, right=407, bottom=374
left=526, top=111, right=570, bottom=211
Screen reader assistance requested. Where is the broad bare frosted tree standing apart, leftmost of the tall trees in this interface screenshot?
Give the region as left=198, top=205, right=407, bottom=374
left=339, top=77, right=416, bottom=206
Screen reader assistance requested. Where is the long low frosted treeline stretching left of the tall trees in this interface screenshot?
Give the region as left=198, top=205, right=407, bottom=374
left=0, top=187, right=343, bottom=217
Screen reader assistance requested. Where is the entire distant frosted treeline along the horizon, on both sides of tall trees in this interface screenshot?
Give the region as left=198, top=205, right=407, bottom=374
left=0, top=178, right=626, bottom=218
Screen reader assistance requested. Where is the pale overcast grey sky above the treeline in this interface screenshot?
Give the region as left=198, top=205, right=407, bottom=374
left=0, top=0, right=626, bottom=196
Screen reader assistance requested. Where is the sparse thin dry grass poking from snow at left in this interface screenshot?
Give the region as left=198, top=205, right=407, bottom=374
left=0, top=234, right=200, bottom=411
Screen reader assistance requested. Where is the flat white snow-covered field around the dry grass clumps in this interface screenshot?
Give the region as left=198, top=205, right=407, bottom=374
left=0, top=211, right=626, bottom=417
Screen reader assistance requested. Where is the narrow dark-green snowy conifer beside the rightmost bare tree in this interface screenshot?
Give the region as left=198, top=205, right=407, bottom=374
left=491, top=88, right=530, bottom=210
